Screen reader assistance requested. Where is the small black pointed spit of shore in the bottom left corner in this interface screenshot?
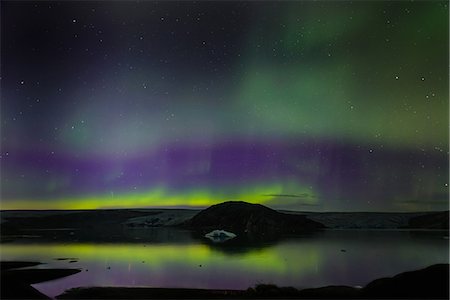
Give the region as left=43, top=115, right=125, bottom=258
left=0, top=261, right=80, bottom=299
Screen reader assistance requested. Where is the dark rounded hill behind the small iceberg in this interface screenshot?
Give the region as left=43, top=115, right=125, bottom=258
left=187, top=201, right=325, bottom=236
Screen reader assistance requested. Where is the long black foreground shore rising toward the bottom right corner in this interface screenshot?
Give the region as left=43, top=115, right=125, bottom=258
left=56, top=264, right=449, bottom=299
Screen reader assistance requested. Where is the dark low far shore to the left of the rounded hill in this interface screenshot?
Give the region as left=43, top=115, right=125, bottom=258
left=0, top=209, right=198, bottom=243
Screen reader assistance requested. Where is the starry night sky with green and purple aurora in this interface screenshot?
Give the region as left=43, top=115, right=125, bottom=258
left=0, top=1, right=449, bottom=211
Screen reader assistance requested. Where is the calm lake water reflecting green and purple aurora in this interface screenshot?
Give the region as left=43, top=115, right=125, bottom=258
left=1, top=229, right=449, bottom=297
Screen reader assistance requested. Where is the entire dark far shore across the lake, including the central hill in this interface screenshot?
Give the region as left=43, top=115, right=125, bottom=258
left=0, top=206, right=449, bottom=242
